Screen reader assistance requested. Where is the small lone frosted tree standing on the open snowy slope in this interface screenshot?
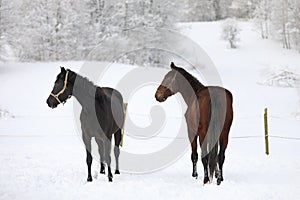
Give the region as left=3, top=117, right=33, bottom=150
left=222, top=19, right=241, bottom=49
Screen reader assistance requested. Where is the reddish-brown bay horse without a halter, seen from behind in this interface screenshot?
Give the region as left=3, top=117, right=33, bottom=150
left=155, top=62, right=233, bottom=185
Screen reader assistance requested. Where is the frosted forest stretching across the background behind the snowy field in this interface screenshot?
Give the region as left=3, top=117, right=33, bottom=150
left=0, top=0, right=300, bottom=63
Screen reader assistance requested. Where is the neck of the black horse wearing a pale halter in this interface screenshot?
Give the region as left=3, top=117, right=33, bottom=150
left=73, top=75, right=97, bottom=110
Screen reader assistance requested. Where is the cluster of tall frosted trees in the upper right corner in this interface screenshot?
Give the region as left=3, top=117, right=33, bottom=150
left=254, top=0, right=300, bottom=52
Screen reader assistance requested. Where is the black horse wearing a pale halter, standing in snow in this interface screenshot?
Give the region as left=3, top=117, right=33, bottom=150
left=47, top=67, right=124, bottom=182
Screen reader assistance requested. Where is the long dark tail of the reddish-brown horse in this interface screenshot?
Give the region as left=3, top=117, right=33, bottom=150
left=207, top=88, right=226, bottom=179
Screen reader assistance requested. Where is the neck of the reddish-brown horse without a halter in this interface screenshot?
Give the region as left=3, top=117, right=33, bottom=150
left=177, top=72, right=205, bottom=105
